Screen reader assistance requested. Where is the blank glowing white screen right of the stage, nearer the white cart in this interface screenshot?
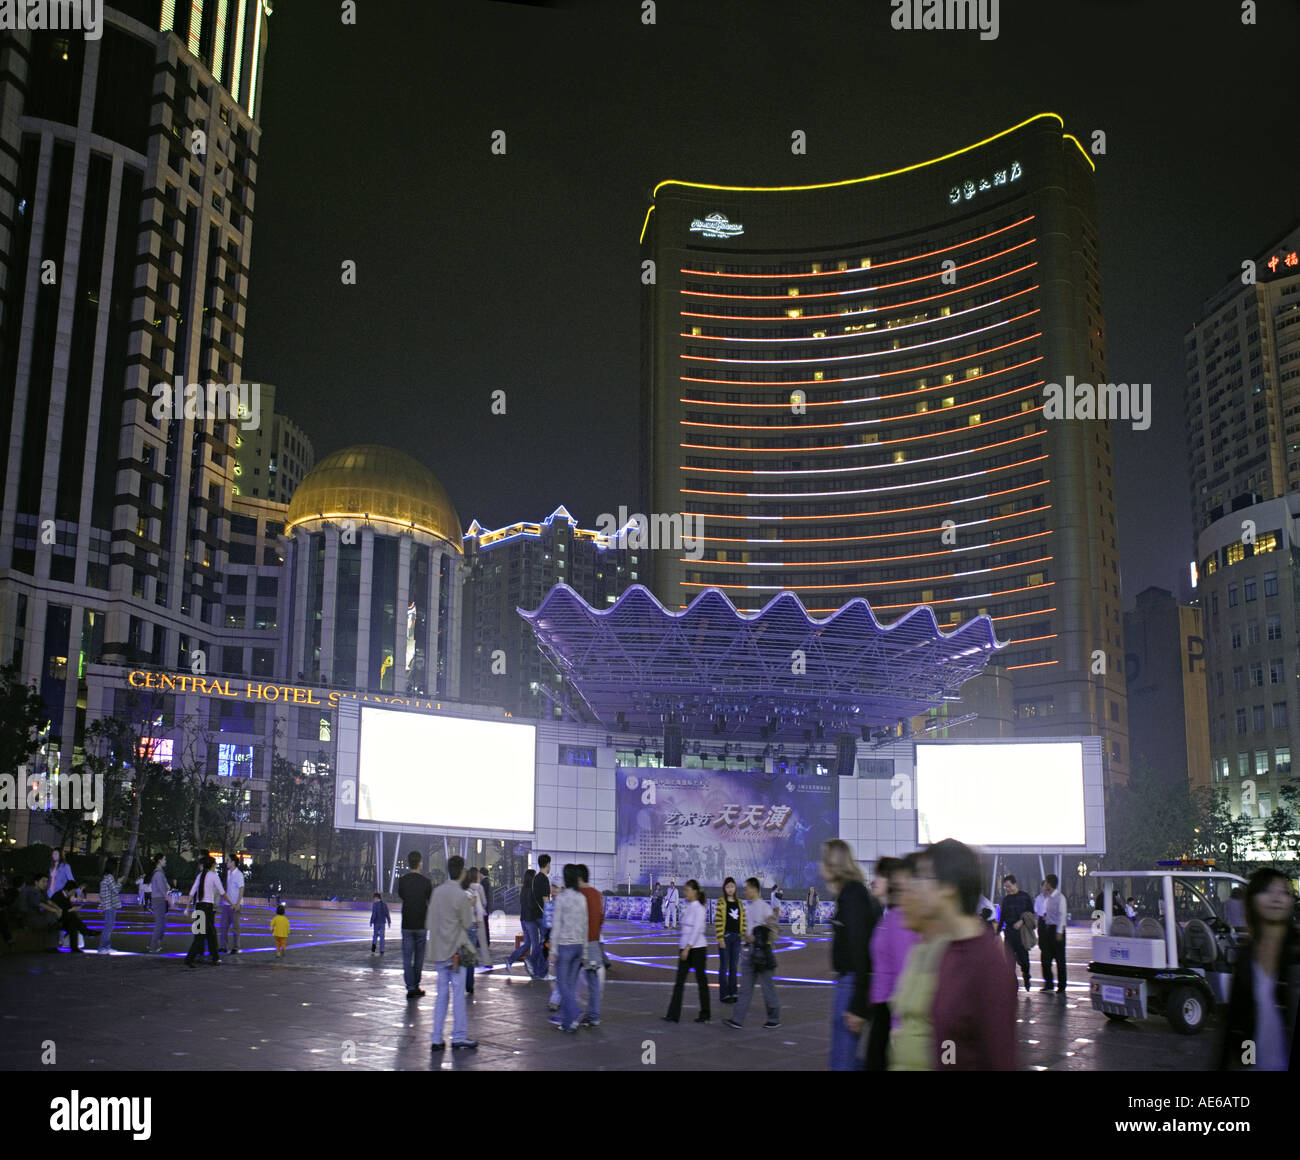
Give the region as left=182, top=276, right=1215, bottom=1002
left=917, top=741, right=1086, bottom=845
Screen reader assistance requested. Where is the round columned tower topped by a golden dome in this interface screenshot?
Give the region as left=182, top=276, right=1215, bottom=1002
left=285, top=443, right=462, bottom=697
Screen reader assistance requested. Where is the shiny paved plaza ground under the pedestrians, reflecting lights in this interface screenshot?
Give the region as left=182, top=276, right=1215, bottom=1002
left=0, top=906, right=1214, bottom=1072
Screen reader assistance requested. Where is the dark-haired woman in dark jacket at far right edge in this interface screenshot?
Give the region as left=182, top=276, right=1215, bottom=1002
left=1218, top=866, right=1300, bottom=1072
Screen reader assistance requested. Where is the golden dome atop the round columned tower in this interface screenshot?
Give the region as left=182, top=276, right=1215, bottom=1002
left=285, top=443, right=462, bottom=551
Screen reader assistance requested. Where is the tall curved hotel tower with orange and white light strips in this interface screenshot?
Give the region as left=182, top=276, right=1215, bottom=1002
left=642, top=113, right=1127, bottom=782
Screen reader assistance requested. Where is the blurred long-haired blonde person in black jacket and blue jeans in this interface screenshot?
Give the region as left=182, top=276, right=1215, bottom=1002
left=820, top=837, right=884, bottom=1072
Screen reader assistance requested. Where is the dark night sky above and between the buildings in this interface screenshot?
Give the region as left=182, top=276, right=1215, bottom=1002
left=244, top=0, right=1300, bottom=606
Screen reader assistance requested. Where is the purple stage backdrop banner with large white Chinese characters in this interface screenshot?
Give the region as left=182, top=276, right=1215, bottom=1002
left=615, top=767, right=840, bottom=890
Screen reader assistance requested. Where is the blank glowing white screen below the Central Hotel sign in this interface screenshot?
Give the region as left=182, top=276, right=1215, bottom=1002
left=356, top=707, right=537, bottom=831
